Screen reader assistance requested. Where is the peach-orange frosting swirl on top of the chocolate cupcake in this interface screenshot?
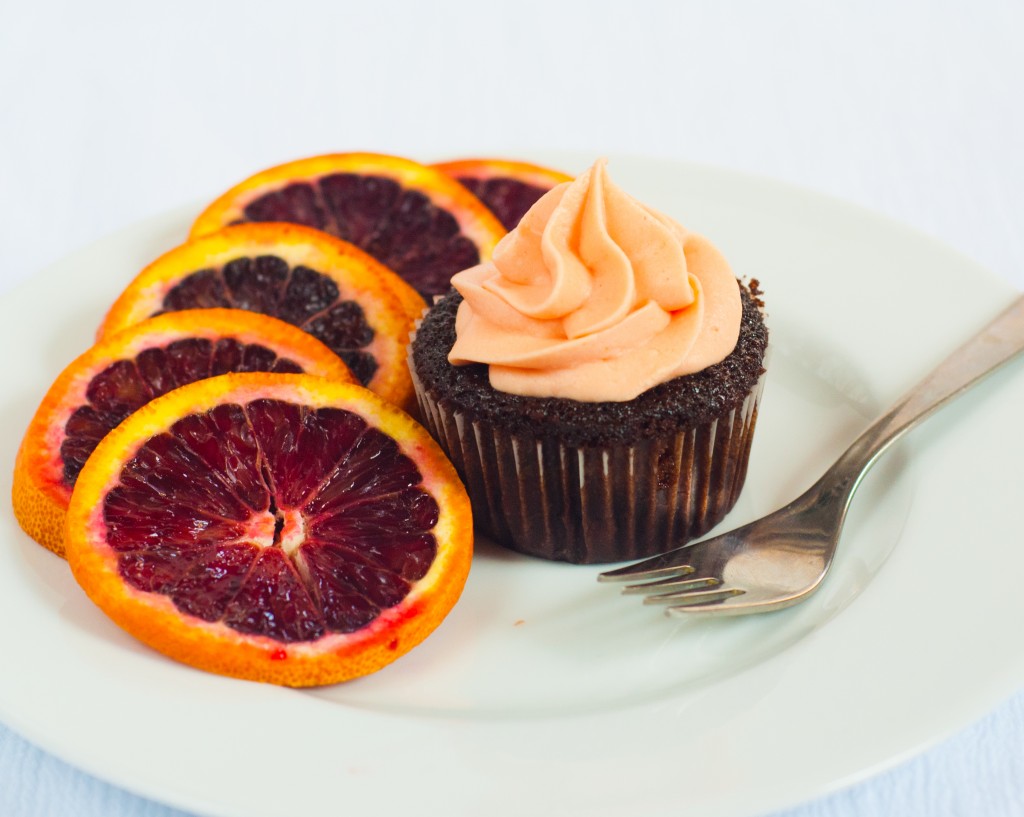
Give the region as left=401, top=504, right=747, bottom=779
left=449, top=160, right=742, bottom=402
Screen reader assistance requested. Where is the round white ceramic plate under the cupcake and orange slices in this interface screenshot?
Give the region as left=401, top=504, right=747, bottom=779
left=0, top=156, right=1024, bottom=817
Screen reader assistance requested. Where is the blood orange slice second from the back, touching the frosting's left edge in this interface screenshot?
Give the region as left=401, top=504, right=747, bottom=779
left=191, top=154, right=505, bottom=300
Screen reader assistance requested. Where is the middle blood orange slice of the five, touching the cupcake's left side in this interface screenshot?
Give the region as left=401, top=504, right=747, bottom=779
left=99, top=223, right=426, bottom=406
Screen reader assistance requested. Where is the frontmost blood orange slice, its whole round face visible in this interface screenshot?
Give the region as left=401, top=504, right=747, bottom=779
left=59, top=374, right=472, bottom=686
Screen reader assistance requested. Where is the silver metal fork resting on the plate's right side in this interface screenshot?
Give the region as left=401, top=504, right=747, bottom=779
left=598, top=297, right=1024, bottom=615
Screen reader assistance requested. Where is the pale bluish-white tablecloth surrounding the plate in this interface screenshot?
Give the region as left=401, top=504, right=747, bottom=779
left=0, top=0, right=1024, bottom=817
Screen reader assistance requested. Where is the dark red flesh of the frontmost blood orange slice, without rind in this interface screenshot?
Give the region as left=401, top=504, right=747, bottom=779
left=103, top=398, right=438, bottom=642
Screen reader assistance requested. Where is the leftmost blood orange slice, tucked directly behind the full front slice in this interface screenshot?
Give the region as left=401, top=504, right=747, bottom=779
left=11, top=309, right=354, bottom=556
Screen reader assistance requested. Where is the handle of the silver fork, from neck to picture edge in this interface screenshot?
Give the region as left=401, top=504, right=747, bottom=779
left=819, top=296, right=1024, bottom=505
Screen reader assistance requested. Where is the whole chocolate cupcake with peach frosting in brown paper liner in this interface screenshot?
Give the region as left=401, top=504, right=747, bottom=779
left=410, top=162, right=768, bottom=563
